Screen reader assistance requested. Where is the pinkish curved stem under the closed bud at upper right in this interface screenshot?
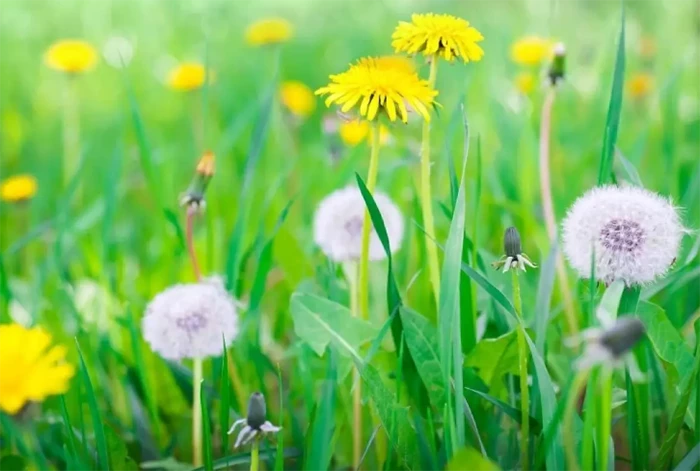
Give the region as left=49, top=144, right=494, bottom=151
left=540, top=87, right=578, bottom=336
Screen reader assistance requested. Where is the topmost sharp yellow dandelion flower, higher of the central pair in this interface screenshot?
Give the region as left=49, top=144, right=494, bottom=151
left=391, top=13, right=484, bottom=62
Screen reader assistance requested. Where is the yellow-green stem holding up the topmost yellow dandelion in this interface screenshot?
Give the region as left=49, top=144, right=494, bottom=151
left=420, top=57, right=440, bottom=305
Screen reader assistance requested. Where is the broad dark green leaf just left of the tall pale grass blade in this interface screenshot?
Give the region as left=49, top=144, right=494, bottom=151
left=400, top=307, right=445, bottom=409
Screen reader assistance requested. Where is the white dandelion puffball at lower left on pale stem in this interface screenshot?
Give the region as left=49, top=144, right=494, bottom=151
left=142, top=278, right=238, bottom=360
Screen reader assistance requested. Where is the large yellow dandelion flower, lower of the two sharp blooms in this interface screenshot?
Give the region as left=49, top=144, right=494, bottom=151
left=316, top=57, right=438, bottom=123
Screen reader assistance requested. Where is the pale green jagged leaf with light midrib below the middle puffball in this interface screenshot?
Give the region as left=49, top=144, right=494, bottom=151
left=290, top=293, right=377, bottom=359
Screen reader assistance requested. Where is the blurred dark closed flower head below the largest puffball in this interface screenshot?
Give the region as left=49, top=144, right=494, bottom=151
left=572, top=316, right=646, bottom=376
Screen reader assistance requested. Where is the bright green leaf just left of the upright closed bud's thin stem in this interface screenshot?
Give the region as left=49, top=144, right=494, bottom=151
left=465, top=330, right=519, bottom=397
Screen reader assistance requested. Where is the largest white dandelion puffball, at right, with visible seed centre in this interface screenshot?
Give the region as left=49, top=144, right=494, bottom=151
left=563, top=186, right=685, bottom=286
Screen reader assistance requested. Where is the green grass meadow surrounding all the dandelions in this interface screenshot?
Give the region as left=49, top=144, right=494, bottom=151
left=0, top=0, right=700, bottom=471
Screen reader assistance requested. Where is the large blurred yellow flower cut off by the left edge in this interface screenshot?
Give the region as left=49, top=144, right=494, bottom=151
left=0, top=324, right=75, bottom=414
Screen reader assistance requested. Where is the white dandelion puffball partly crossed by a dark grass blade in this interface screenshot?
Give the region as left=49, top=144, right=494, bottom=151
left=314, top=186, right=403, bottom=262
